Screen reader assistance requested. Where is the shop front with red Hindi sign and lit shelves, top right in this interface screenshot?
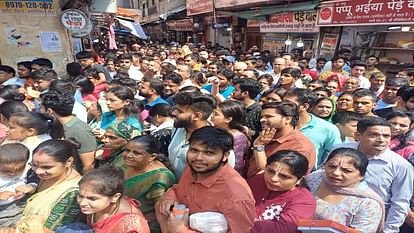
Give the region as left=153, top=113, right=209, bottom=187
left=317, top=0, right=414, bottom=74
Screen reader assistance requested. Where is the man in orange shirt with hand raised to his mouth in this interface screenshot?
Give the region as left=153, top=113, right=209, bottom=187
left=247, top=102, right=316, bottom=178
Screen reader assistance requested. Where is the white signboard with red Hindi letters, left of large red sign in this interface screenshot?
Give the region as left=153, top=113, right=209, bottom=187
left=260, top=11, right=319, bottom=33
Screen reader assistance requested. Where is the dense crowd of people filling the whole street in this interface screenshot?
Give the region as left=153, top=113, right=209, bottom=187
left=0, top=43, right=414, bottom=233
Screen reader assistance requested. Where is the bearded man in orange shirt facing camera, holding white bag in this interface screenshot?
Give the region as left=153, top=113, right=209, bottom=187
left=155, top=126, right=255, bottom=233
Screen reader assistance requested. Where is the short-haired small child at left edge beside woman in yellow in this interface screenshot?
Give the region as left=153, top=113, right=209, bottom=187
left=0, top=143, right=37, bottom=227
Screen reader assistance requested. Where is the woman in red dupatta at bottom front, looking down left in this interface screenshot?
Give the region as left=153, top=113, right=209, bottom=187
left=78, top=166, right=150, bottom=233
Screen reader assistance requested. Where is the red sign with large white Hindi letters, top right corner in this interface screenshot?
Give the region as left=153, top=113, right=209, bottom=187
left=317, top=0, right=414, bottom=26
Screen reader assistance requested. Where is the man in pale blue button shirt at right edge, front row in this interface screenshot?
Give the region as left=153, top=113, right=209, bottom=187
left=334, top=117, right=414, bottom=233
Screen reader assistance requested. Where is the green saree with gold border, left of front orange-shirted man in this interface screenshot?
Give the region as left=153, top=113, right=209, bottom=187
left=125, top=168, right=176, bottom=233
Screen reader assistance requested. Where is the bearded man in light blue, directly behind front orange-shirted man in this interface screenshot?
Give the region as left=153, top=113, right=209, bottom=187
left=168, top=92, right=216, bottom=178
